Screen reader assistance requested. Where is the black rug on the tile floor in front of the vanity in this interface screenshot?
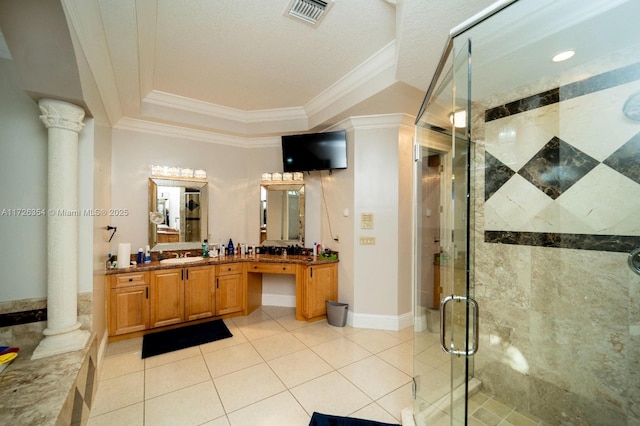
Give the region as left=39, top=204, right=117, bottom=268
left=142, top=319, right=233, bottom=358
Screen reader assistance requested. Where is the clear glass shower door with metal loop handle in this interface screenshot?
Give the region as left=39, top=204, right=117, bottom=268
left=413, top=37, right=478, bottom=425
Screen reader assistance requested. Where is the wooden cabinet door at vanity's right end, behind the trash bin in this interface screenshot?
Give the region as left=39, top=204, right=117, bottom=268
left=304, top=263, right=338, bottom=319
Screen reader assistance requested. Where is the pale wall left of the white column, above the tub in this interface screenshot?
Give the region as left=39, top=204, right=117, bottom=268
left=0, top=58, right=48, bottom=302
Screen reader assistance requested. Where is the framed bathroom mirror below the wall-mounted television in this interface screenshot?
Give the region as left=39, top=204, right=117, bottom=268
left=260, top=183, right=304, bottom=246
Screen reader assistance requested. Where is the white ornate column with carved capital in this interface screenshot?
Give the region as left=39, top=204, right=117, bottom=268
left=32, top=99, right=90, bottom=359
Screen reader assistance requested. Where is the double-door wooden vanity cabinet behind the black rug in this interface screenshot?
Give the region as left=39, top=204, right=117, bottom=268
left=151, top=266, right=215, bottom=327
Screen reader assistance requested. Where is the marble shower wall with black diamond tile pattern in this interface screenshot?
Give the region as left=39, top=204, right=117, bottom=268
left=472, top=60, right=640, bottom=424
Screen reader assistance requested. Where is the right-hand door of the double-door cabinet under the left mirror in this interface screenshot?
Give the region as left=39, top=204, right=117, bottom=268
left=184, top=266, right=215, bottom=321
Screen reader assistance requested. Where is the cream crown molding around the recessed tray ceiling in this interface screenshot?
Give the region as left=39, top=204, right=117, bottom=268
left=62, top=0, right=404, bottom=137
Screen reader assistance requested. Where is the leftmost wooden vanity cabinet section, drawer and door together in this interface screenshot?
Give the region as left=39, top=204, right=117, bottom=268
left=107, top=272, right=149, bottom=336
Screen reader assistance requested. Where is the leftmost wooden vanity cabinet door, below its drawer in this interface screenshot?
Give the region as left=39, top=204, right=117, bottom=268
left=109, top=285, right=149, bottom=336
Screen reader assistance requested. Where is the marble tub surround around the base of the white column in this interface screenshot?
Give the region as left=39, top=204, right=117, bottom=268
left=0, top=293, right=98, bottom=426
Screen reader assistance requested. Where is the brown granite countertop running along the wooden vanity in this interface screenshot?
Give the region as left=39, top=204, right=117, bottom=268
left=105, top=254, right=338, bottom=275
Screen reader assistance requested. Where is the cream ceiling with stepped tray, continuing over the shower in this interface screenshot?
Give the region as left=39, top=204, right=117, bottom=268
left=0, top=0, right=640, bottom=146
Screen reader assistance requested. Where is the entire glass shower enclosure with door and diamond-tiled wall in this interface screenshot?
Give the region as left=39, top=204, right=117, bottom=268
left=413, top=0, right=640, bottom=425
